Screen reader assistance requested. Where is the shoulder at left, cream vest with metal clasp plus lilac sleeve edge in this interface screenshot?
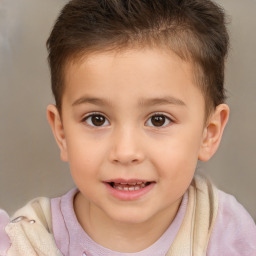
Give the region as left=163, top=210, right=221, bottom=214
left=0, top=197, right=62, bottom=256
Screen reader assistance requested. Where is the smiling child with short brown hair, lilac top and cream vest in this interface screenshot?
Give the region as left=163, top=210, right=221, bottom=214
left=0, top=0, right=256, bottom=256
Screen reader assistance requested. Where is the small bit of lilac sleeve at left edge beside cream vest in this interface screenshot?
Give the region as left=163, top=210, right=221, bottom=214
left=0, top=209, right=11, bottom=255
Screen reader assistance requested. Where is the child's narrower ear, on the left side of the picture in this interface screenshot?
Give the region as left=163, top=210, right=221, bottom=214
left=47, top=105, right=68, bottom=162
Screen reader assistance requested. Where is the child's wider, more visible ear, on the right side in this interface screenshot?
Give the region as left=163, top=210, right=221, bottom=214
left=198, top=104, right=229, bottom=161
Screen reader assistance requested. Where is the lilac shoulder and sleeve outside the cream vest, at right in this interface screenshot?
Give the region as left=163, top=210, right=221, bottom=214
left=207, top=191, right=256, bottom=256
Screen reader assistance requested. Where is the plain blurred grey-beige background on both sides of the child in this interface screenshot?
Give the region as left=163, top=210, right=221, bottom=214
left=0, top=0, right=256, bottom=219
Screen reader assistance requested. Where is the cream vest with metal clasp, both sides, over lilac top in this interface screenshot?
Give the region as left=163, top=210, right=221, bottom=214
left=6, top=176, right=218, bottom=256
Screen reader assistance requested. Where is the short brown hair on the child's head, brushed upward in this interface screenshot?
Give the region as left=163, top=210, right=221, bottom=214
left=47, top=0, right=229, bottom=116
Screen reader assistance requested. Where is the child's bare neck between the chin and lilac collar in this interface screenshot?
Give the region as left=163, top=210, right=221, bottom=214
left=74, top=193, right=182, bottom=253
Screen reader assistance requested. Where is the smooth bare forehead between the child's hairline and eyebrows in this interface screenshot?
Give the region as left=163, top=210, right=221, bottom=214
left=63, top=48, right=203, bottom=109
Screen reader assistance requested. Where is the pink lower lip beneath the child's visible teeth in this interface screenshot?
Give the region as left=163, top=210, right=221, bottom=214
left=105, top=182, right=155, bottom=201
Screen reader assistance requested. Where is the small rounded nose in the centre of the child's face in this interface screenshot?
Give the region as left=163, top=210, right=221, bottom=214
left=109, top=128, right=145, bottom=165
